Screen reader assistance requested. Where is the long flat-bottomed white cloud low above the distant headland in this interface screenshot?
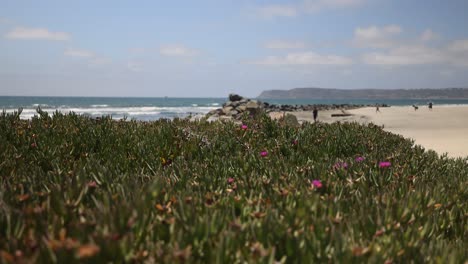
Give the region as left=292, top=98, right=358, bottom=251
left=251, top=51, right=352, bottom=66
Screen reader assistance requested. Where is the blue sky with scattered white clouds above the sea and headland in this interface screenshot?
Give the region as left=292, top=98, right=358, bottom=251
left=0, top=0, right=468, bottom=97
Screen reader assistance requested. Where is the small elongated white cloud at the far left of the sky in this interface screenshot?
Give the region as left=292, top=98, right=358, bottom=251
left=5, top=27, right=71, bottom=41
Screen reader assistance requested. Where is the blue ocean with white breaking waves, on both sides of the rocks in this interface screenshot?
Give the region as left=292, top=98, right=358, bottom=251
left=0, top=96, right=468, bottom=121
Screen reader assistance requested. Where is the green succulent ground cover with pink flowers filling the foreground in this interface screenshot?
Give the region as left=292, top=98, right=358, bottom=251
left=0, top=110, right=468, bottom=263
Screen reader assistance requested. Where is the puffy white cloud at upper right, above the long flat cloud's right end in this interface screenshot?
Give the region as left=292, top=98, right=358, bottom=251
left=353, top=25, right=403, bottom=48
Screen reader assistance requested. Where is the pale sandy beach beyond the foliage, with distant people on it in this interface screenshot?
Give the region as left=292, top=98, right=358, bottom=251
left=294, top=105, right=468, bottom=157
